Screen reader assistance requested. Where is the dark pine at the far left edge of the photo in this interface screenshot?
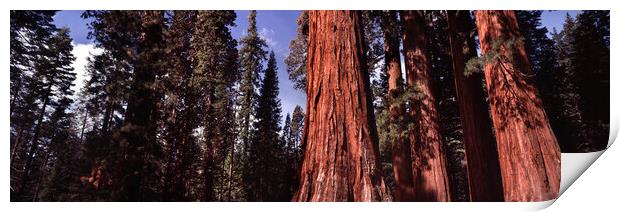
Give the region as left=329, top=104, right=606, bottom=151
left=9, top=10, right=57, bottom=200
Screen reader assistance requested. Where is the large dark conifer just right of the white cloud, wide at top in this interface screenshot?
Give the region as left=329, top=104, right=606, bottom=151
left=82, top=11, right=166, bottom=201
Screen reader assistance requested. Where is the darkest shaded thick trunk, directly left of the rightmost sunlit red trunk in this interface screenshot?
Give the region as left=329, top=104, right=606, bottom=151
left=447, top=11, right=503, bottom=202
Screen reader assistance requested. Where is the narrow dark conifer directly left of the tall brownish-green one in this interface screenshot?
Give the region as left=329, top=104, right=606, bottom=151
left=159, top=11, right=200, bottom=201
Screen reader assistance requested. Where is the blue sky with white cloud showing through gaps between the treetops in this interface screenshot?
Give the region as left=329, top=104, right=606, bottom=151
left=54, top=10, right=579, bottom=121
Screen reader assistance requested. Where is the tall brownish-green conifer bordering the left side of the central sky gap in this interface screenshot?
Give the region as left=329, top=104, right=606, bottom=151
left=190, top=11, right=239, bottom=201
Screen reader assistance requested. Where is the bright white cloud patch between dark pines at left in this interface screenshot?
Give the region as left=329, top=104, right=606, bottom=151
left=71, top=43, right=103, bottom=94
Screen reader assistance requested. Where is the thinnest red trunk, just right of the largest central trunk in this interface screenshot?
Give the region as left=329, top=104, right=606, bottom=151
left=383, top=11, right=413, bottom=201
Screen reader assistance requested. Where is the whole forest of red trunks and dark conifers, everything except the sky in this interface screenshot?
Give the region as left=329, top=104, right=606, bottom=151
left=10, top=10, right=610, bottom=201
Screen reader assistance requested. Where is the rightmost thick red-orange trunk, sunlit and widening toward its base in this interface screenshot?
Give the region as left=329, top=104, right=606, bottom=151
left=476, top=11, right=560, bottom=201
